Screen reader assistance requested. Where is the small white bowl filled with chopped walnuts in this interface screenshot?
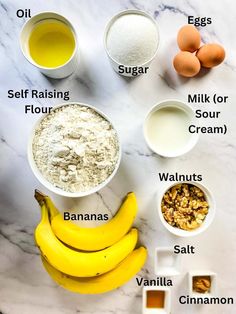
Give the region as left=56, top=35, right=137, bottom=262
left=158, top=182, right=215, bottom=237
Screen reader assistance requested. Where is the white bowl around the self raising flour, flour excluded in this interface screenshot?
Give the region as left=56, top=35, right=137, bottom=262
left=28, top=102, right=121, bottom=197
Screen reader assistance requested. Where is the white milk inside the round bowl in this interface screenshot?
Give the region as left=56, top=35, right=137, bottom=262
left=146, top=106, right=191, bottom=155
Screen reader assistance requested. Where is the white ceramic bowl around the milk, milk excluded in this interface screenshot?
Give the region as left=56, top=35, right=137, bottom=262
left=143, top=99, right=199, bottom=157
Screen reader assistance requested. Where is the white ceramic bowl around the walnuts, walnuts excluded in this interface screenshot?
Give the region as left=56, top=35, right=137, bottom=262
left=158, top=182, right=215, bottom=237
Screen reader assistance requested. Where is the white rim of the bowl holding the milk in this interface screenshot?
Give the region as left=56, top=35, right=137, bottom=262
left=143, top=98, right=199, bottom=158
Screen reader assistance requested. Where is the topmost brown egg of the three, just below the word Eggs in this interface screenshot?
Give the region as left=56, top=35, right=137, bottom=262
left=177, top=25, right=201, bottom=52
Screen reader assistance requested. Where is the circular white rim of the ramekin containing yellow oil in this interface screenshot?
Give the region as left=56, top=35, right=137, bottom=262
left=19, top=11, right=78, bottom=70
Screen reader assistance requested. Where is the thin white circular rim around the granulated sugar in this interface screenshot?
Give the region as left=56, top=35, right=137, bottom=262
left=103, top=9, right=160, bottom=68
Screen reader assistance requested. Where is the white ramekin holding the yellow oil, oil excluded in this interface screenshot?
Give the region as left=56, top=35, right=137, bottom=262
left=20, top=12, right=79, bottom=79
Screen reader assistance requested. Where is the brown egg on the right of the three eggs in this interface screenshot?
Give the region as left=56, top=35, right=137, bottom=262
left=196, top=44, right=225, bottom=68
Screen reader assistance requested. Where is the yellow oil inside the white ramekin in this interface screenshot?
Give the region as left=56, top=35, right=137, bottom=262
left=29, top=19, right=75, bottom=68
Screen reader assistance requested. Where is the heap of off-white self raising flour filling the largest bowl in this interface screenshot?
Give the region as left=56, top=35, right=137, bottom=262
left=32, top=104, right=119, bottom=192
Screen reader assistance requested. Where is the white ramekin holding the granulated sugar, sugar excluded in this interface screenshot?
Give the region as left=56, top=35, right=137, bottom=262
left=103, top=9, right=160, bottom=77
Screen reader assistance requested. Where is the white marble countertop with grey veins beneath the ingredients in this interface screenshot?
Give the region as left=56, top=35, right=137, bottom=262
left=0, top=0, right=236, bottom=314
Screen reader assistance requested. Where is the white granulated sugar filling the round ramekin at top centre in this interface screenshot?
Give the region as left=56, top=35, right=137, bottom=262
left=107, top=13, right=159, bottom=66
